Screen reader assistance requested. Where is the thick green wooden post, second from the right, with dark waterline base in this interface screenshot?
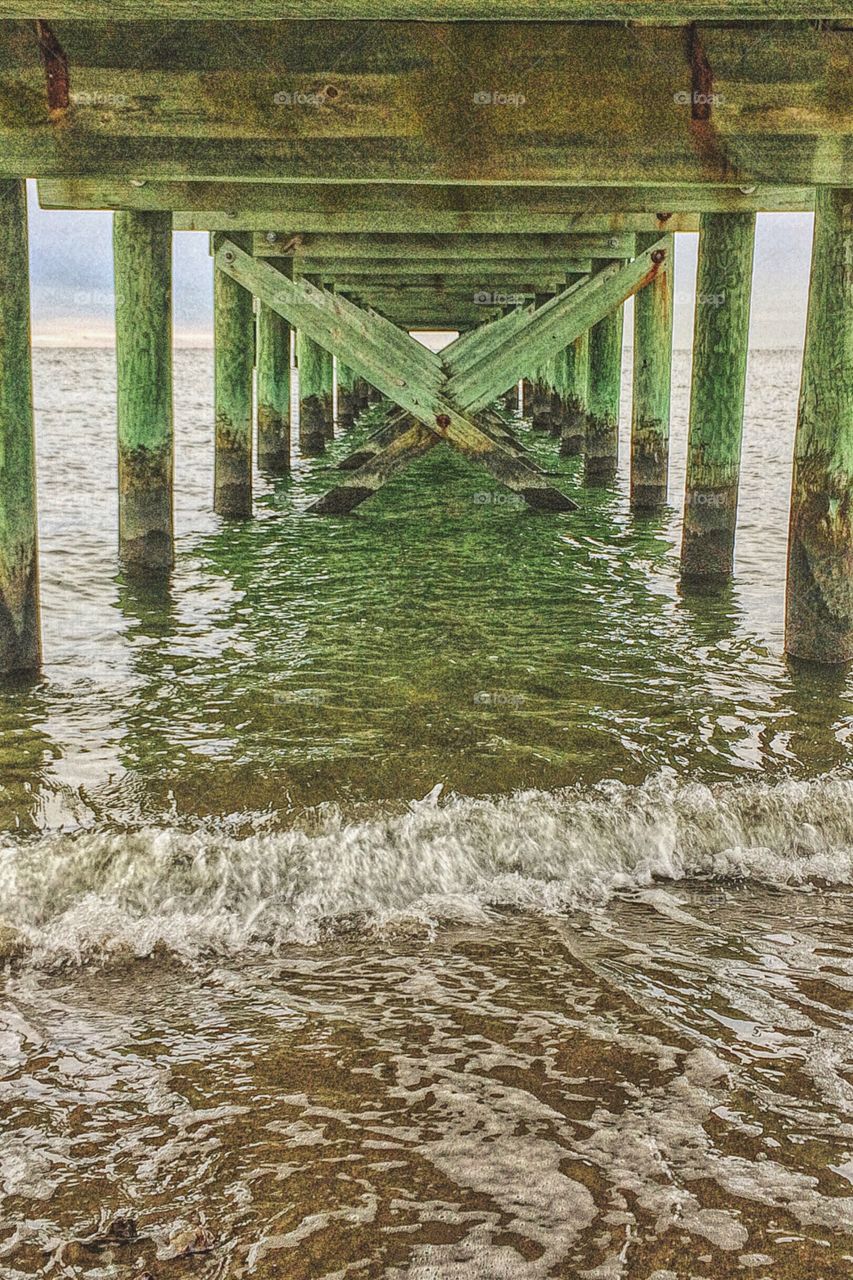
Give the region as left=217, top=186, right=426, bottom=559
left=681, top=214, right=756, bottom=580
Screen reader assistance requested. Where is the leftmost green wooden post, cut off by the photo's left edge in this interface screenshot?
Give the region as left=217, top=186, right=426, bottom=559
left=0, top=179, right=41, bottom=675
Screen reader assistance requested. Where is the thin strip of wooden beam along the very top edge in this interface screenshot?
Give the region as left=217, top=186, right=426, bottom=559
left=3, top=0, right=849, bottom=17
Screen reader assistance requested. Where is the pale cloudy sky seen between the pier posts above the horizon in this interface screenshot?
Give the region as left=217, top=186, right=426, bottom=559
left=23, top=183, right=812, bottom=348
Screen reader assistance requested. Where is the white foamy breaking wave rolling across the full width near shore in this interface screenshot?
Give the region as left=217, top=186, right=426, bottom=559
left=0, top=777, right=853, bottom=968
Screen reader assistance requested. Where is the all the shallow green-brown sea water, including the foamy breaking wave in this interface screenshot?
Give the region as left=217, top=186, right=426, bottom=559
left=0, top=351, right=853, bottom=1280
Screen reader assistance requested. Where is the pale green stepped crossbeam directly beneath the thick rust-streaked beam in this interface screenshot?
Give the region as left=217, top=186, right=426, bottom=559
left=38, top=180, right=815, bottom=222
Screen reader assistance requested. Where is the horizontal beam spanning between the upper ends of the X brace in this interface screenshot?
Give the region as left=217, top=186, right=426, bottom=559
left=252, top=232, right=637, bottom=259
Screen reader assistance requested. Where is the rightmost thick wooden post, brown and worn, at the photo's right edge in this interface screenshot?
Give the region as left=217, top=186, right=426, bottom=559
left=785, top=187, right=853, bottom=663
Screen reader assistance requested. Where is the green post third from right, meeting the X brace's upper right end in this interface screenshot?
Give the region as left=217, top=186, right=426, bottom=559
left=631, top=232, right=675, bottom=508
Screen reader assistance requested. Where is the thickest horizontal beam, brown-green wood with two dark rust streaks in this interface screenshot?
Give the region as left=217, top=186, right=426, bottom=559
left=0, top=22, right=853, bottom=187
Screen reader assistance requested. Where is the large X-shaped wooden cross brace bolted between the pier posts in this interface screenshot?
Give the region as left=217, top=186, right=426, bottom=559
left=215, top=238, right=666, bottom=513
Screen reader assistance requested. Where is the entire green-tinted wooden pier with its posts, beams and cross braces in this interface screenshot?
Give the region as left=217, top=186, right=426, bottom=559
left=0, top=0, right=853, bottom=673
